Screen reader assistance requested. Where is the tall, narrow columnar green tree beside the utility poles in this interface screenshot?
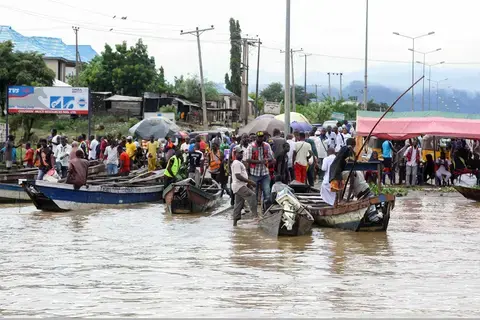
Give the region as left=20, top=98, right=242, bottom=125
left=225, top=18, right=242, bottom=97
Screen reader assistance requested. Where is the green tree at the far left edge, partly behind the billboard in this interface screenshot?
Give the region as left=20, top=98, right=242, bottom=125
left=0, top=41, right=55, bottom=141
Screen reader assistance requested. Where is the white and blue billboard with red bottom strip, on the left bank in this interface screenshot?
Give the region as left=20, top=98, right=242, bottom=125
left=8, top=86, right=89, bottom=114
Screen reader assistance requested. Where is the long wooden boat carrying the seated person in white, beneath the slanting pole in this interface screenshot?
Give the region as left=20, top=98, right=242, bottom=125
left=290, top=185, right=395, bottom=231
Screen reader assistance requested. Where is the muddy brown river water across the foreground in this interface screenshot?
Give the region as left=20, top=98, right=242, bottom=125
left=0, top=193, right=480, bottom=317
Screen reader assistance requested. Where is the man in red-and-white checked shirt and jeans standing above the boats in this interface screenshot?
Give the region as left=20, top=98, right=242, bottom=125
left=245, top=131, right=273, bottom=209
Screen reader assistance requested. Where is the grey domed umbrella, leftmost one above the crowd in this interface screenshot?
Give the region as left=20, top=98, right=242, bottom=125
left=128, top=117, right=180, bottom=139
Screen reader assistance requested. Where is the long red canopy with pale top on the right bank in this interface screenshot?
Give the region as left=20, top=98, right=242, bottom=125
left=357, top=111, right=480, bottom=140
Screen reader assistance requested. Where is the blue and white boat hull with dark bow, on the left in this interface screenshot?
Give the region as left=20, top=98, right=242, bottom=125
left=23, top=181, right=163, bottom=212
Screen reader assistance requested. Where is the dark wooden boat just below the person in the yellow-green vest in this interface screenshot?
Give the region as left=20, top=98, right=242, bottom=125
left=163, top=178, right=222, bottom=214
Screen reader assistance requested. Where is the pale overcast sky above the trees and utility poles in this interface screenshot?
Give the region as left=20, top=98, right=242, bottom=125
left=0, top=0, right=480, bottom=90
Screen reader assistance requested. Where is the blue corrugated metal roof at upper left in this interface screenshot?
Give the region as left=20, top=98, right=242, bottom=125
left=0, top=26, right=97, bottom=62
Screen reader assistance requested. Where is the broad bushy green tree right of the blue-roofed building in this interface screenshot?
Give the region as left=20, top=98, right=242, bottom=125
left=74, top=39, right=158, bottom=96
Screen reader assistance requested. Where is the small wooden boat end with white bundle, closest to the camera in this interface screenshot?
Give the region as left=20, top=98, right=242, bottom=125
left=258, top=204, right=314, bottom=237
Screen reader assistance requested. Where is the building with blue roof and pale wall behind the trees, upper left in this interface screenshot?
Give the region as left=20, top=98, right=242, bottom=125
left=0, top=26, right=97, bottom=82
